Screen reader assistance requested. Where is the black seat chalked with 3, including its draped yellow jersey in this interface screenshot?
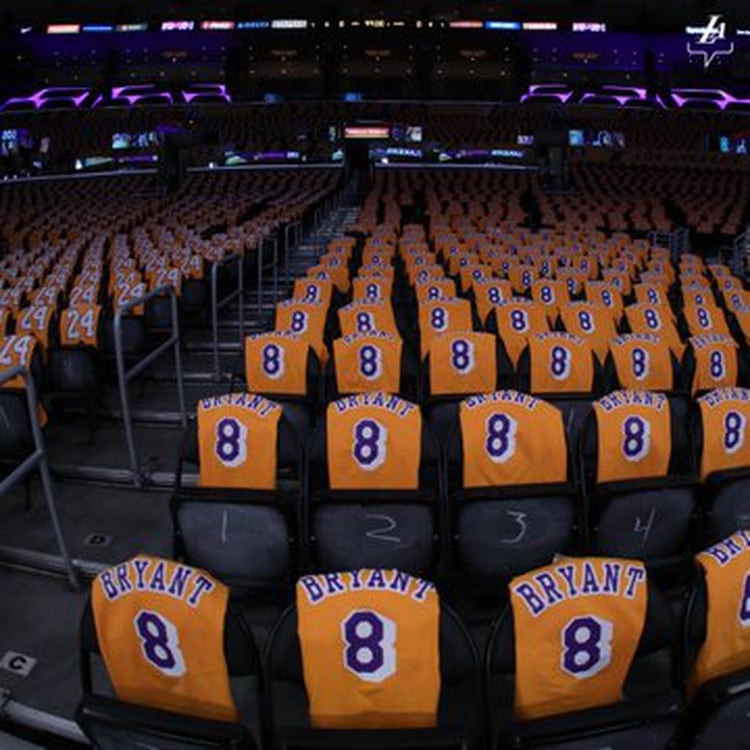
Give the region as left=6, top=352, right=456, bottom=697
left=445, top=391, right=578, bottom=587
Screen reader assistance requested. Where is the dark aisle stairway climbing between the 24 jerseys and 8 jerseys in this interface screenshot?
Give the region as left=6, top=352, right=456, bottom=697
left=0, top=194, right=357, bottom=747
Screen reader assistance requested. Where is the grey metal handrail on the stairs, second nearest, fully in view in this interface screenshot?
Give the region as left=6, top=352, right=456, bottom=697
left=114, top=284, right=187, bottom=487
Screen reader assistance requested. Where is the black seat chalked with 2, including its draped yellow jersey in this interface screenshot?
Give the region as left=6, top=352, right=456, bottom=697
left=305, top=394, right=441, bottom=574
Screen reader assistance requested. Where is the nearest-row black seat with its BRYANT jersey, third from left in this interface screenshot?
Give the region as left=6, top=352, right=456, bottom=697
left=485, top=558, right=682, bottom=750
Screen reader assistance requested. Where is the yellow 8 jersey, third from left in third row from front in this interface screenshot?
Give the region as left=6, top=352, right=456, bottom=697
left=429, top=331, right=497, bottom=396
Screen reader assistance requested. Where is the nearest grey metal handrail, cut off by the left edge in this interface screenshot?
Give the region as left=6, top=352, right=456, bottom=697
left=0, top=367, right=78, bottom=588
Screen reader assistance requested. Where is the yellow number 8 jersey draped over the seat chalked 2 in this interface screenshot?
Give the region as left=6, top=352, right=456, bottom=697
left=326, top=393, right=422, bottom=490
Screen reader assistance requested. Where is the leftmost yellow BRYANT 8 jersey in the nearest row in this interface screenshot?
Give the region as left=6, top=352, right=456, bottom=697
left=91, top=555, right=238, bottom=722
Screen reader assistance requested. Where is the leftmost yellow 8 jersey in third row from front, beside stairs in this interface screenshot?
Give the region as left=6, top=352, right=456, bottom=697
left=245, top=331, right=310, bottom=396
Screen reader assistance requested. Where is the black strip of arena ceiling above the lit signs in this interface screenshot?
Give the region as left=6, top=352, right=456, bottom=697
left=0, top=0, right=750, bottom=30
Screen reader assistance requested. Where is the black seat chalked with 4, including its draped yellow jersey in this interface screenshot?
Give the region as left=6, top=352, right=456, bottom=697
left=579, top=391, right=697, bottom=574
